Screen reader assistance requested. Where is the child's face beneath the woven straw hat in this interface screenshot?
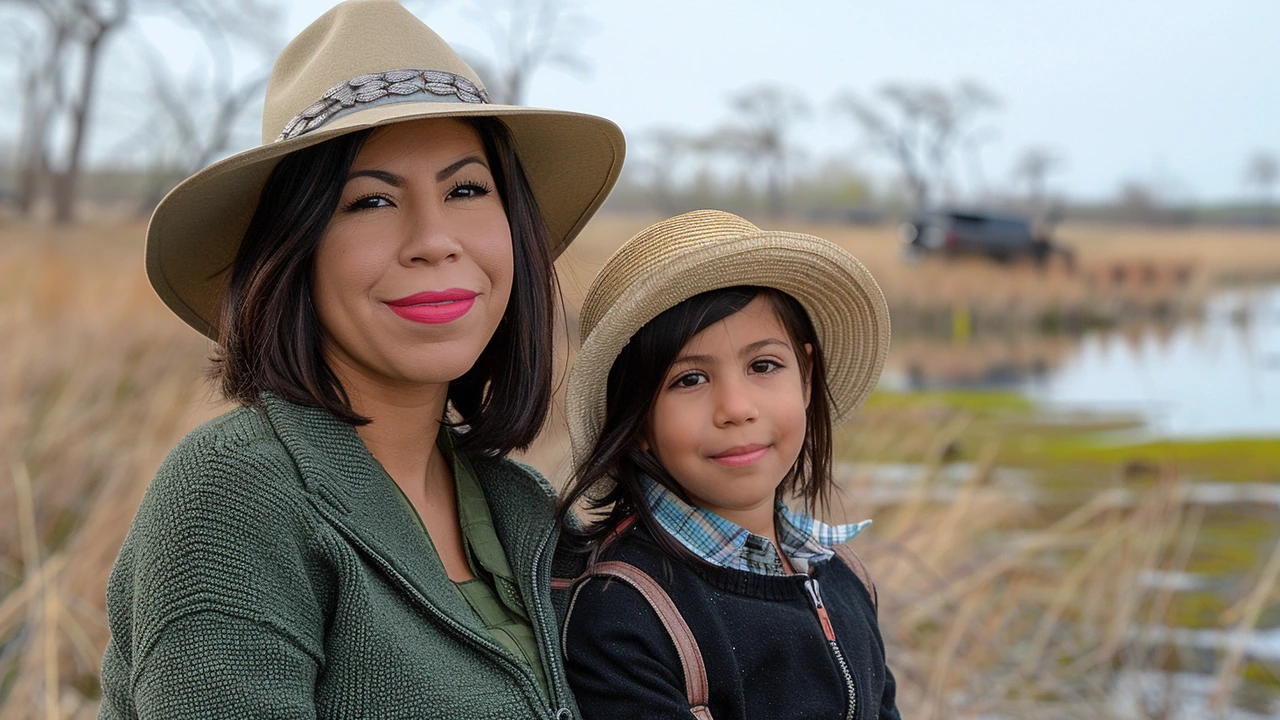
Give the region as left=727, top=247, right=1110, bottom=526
left=645, top=297, right=809, bottom=529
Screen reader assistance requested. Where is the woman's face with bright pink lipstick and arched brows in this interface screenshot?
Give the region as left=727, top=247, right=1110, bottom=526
left=311, top=119, right=512, bottom=392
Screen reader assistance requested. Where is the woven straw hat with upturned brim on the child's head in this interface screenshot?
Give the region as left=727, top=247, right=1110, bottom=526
left=566, top=210, right=890, bottom=464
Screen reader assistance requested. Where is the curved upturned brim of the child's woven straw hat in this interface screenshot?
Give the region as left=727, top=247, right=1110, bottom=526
left=566, top=231, right=890, bottom=466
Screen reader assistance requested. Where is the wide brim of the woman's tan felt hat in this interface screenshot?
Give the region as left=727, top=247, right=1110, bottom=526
left=146, top=102, right=626, bottom=340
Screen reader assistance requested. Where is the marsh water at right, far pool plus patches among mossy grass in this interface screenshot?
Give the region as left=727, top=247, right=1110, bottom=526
left=861, top=284, right=1280, bottom=720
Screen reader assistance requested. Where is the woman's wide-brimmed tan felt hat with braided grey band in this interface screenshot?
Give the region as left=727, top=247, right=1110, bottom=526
left=146, top=0, right=625, bottom=340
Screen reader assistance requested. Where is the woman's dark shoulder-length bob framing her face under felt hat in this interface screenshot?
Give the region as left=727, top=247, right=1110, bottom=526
left=210, top=118, right=558, bottom=455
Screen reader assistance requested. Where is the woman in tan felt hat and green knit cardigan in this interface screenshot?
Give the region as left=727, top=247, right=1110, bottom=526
left=100, top=0, right=622, bottom=719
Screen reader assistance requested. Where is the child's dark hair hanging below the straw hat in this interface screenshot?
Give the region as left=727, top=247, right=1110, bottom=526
left=558, top=286, right=831, bottom=564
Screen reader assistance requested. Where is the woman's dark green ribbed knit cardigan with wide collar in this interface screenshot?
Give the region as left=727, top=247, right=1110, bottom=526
left=99, top=396, right=577, bottom=720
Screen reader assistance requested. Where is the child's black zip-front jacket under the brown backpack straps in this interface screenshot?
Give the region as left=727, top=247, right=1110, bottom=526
left=563, top=523, right=899, bottom=720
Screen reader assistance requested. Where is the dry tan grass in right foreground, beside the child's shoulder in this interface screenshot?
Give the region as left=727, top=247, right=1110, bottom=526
left=837, top=435, right=1228, bottom=720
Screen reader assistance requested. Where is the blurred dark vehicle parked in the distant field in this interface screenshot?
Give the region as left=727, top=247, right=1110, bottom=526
left=899, top=210, right=1074, bottom=268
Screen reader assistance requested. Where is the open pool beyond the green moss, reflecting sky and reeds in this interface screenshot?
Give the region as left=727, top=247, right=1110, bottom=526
left=886, top=286, right=1280, bottom=437
